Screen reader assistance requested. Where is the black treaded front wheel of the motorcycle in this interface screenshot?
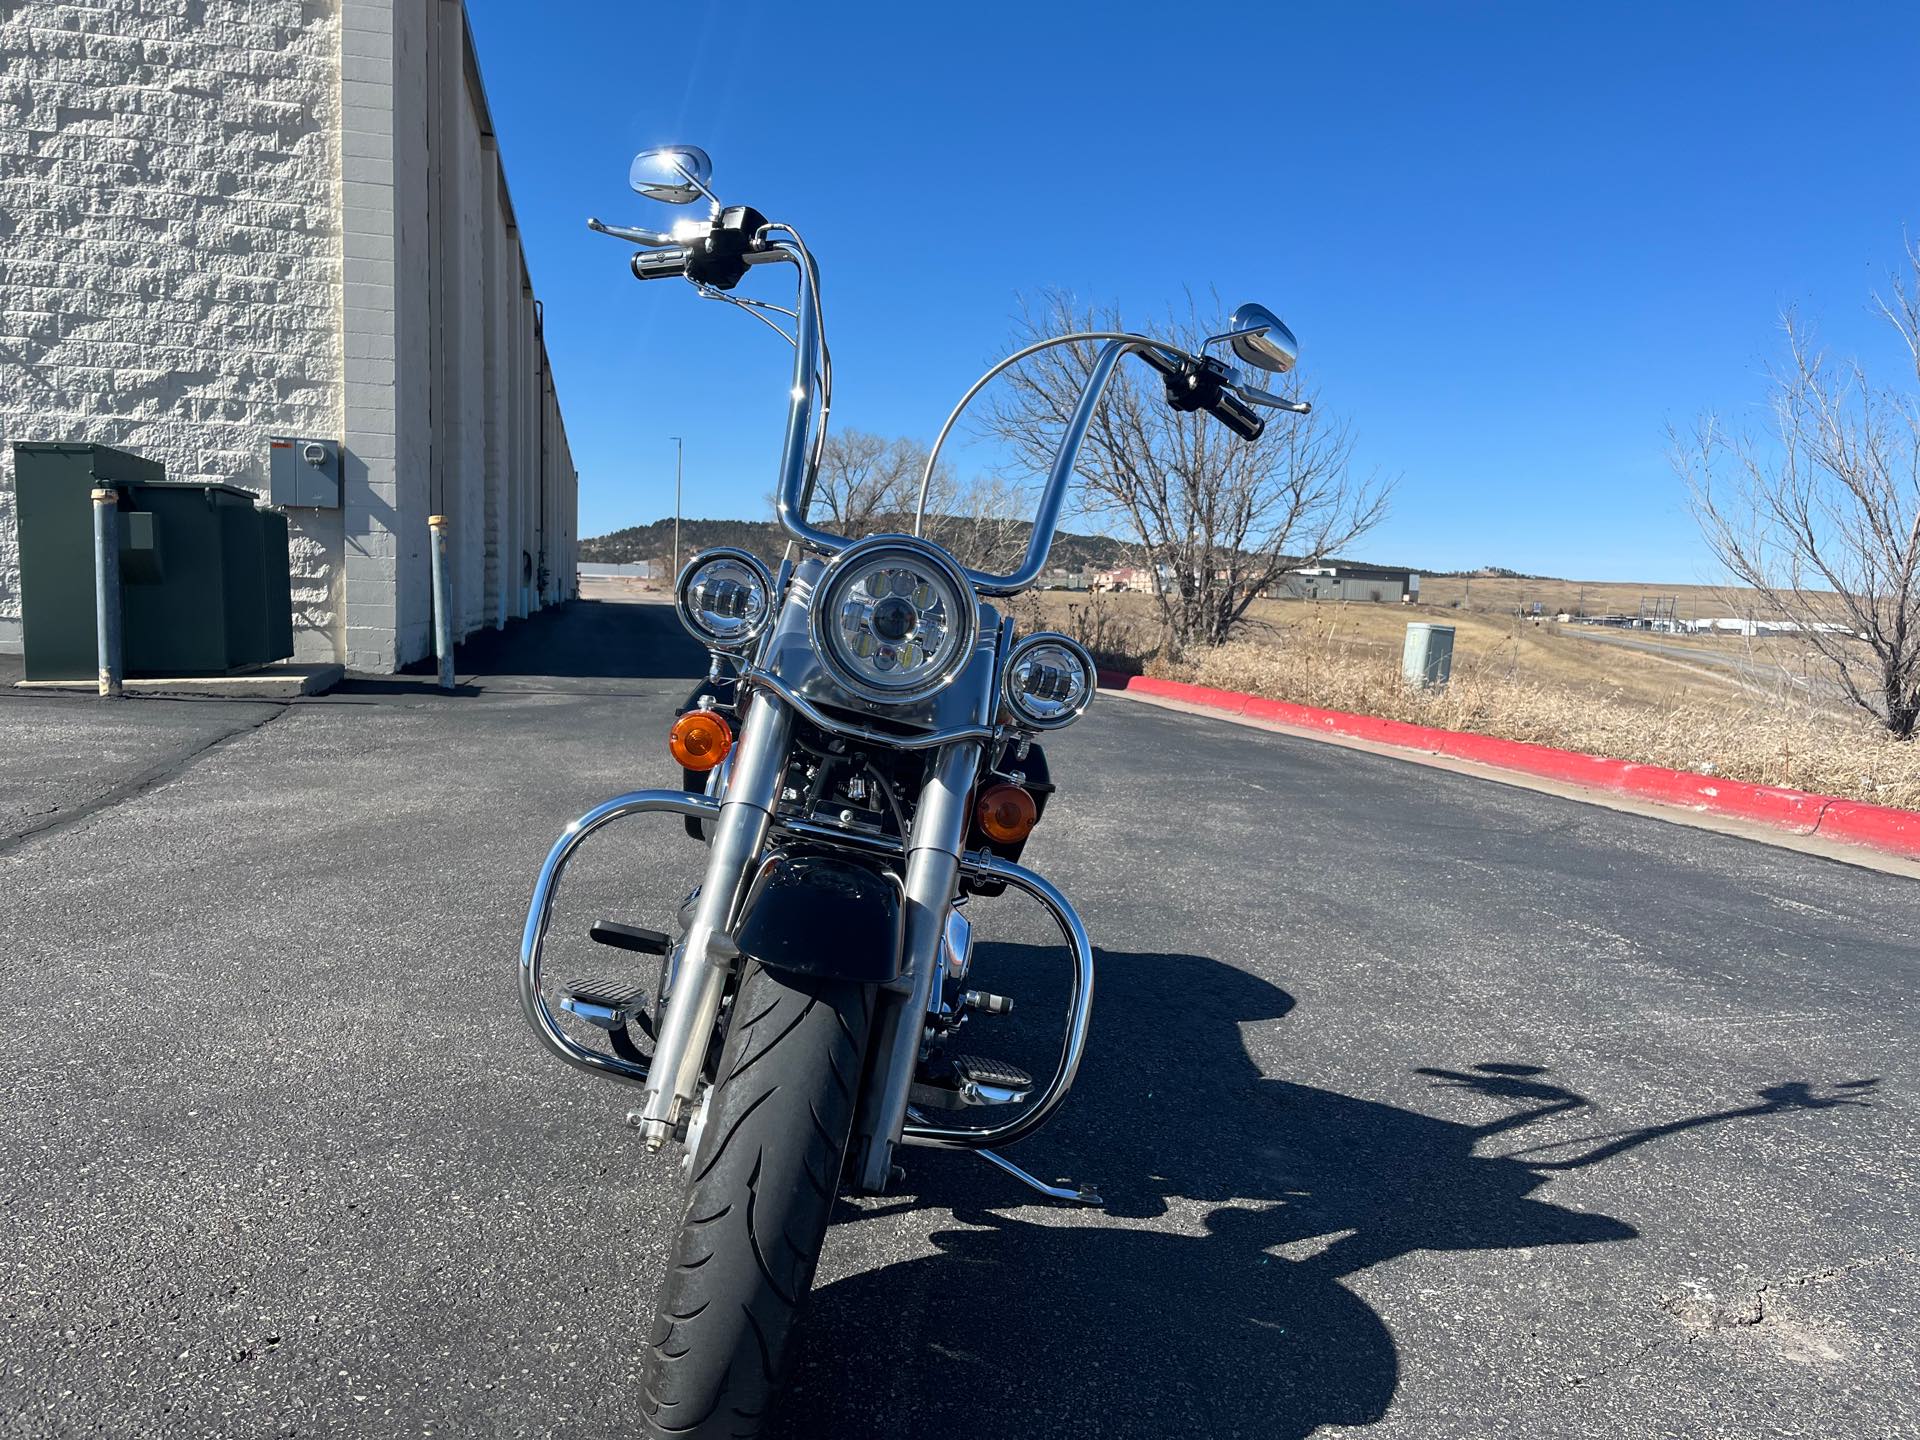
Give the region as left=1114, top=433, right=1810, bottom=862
left=643, top=964, right=874, bottom=1440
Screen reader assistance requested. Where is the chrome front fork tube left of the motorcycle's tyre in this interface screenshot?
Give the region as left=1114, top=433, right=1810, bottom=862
left=639, top=689, right=793, bottom=1150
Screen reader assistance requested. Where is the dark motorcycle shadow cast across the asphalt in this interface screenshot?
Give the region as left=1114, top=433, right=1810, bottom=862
left=778, top=947, right=1872, bottom=1440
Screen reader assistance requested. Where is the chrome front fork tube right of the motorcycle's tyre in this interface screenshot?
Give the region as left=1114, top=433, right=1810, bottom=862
left=858, top=739, right=981, bottom=1194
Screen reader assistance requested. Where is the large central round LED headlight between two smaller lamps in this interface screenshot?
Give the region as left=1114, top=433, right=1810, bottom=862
left=812, top=536, right=979, bottom=705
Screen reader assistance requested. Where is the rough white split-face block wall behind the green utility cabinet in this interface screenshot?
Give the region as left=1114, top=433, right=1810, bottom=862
left=0, top=0, right=342, bottom=659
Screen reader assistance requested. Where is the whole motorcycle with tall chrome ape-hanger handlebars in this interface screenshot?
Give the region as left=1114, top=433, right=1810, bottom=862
left=520, top=146, right=1308, bottom=1436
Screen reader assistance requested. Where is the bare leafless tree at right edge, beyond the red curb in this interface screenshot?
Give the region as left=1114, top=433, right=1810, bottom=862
left=1672, top=246, right=1920, bottom=739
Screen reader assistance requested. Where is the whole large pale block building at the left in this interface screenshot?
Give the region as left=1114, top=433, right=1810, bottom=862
left=0, top=0, right=578, bottom=670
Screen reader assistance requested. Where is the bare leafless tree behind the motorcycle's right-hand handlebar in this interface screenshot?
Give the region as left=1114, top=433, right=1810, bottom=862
left=983, top=292, right=1392, bottom=649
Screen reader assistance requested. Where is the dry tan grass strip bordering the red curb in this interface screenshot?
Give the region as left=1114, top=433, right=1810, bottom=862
left=1020, top=593, right=1920, bottom=808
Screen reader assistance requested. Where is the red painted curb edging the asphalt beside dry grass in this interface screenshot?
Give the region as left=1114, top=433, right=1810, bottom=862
left=1121, top=676, right=1920, bottom=856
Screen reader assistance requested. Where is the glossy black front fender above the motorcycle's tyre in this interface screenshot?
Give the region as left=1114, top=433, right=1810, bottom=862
left=733, top=851, right=906, bottom=985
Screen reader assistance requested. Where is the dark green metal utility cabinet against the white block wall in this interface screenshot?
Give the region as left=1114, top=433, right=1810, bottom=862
left=13, top=444, right=294, bottom=680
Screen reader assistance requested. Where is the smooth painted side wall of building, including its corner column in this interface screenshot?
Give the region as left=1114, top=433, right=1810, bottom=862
left=342, top=0, right=578, bottom=670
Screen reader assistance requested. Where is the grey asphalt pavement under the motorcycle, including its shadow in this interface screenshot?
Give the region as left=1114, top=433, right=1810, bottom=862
left=0, top=601, right=1920, bottom=1440
